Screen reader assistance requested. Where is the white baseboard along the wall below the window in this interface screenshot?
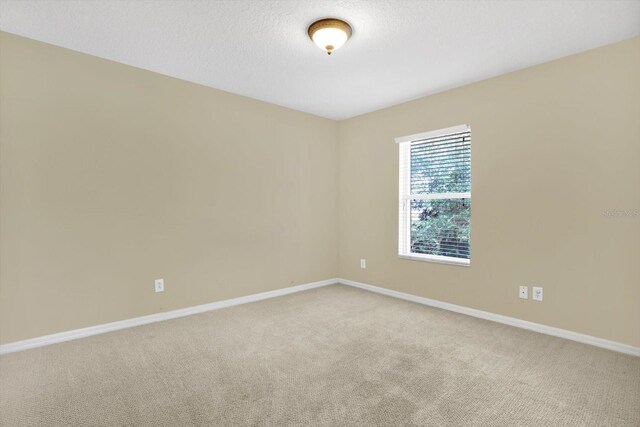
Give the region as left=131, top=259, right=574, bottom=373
left=337, top=279, right=640, bottom=356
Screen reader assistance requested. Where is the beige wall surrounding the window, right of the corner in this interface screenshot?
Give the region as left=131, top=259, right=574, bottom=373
left=339, top=38, right=640, bottom=346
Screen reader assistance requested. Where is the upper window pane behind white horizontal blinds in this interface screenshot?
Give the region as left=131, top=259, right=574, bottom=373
left=411, top=132, right=471, bottom=194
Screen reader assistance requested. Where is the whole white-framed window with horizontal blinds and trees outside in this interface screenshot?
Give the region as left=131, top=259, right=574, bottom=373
left=396, top=125, right=471, bottom=265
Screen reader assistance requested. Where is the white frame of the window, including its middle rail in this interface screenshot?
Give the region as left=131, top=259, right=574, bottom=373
left=395, top=125, right=471, bottom=267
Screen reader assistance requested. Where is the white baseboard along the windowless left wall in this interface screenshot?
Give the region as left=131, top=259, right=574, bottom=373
left=0, top=279, right=338, bottom=355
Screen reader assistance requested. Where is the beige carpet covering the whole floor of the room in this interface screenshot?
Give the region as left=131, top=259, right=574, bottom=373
left=0, top=285, right=640, bottom=427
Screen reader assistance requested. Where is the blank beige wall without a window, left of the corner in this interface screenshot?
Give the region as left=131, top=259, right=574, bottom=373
left=0, top=33, right=338, bottom=343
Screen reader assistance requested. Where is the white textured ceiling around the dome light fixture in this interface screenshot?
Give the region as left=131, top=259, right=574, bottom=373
left=0, top=0, right=640, bottom=119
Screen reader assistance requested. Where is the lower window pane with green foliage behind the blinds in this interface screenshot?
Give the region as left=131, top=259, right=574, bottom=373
left=411, top=199, right=471, bottom=259
